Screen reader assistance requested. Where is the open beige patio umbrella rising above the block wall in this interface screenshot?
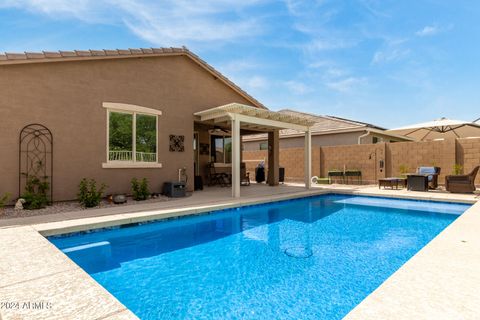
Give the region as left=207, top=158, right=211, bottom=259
left=387, top=118, right=480, bottom=141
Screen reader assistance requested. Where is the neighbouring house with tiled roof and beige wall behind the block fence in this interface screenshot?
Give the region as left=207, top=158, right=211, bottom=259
left=243, top=109, right=412, bottom=151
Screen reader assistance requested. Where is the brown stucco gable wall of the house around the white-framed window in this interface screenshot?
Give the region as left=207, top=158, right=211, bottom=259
left=0, top=56, right=251, bottom=200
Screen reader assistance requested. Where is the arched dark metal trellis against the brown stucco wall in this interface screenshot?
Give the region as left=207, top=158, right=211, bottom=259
left=18, top=123, right=53, bottom=202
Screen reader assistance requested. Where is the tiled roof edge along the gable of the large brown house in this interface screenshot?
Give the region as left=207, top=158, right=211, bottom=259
left=0, top=47, right=267, bottom=109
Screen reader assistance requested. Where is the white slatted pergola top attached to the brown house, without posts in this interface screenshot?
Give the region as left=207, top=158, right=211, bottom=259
left=194, top=103, right=315, bottom=132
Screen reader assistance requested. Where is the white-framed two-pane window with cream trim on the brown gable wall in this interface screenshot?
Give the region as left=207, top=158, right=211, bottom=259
left=103, top=103, right=161, bottom=168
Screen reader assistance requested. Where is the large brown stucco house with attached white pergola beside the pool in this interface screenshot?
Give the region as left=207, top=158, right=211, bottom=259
left=0, top=48, right=312, bottom=201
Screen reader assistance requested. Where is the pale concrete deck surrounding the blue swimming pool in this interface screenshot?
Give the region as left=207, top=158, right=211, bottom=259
left=0, top=184, right=480, bottom=319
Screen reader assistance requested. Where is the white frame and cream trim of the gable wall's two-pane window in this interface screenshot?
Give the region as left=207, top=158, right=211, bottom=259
left=102, top=102, right=162, bottom=169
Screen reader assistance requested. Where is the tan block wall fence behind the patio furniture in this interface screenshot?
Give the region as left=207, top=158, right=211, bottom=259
left=243, top=138, right=480, bottom=184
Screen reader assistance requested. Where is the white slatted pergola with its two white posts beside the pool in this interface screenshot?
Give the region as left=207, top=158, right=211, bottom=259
left=194, top=103, right=315, bottom=197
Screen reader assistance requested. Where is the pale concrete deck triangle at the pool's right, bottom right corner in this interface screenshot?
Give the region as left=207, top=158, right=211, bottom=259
left=344, top=202, right=480, bottom=320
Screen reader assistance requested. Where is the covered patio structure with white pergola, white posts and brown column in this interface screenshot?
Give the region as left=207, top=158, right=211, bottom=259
left=194, top=103, right=314, bottom=198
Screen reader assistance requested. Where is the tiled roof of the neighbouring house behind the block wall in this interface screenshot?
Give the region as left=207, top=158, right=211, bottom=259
left=244, top=109, right=389, bottom=141
